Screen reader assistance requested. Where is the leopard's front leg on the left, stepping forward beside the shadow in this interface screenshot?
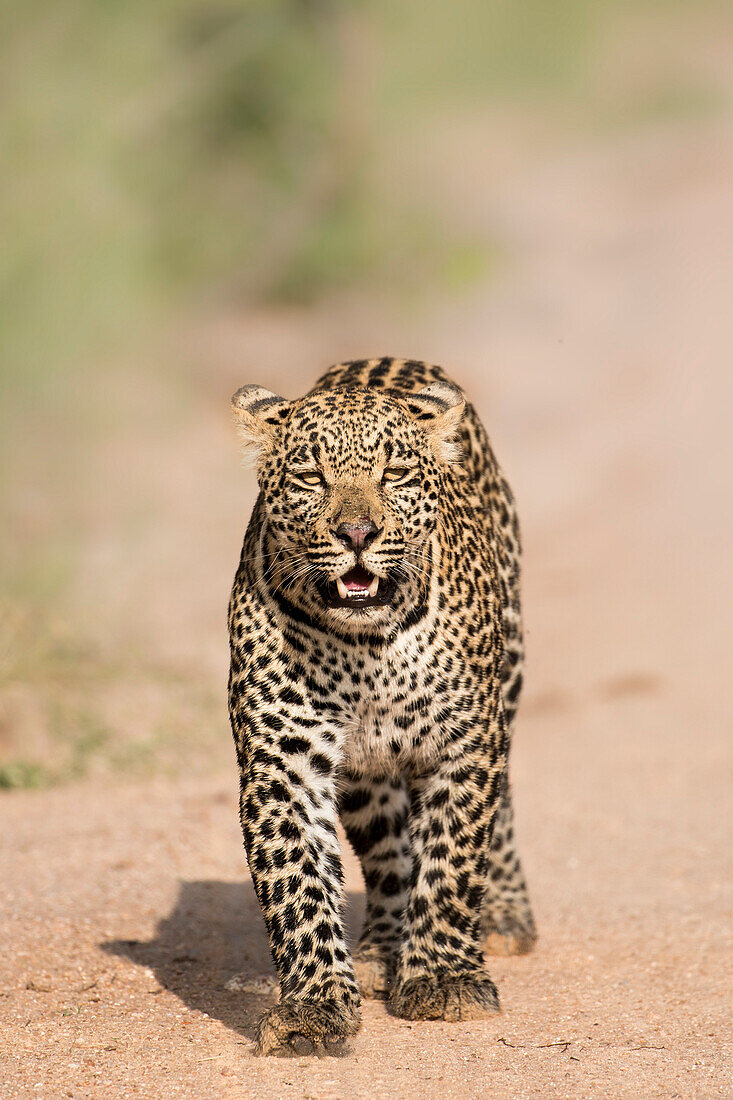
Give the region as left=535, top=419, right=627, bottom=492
left=234, top=711, right=360, bottom=1054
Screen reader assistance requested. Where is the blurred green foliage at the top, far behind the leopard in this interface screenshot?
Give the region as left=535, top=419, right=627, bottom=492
left=0, top=0, right=717, bottom=396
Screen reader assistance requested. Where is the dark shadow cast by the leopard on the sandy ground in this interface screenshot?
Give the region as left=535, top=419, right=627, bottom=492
left=100, top=880, right=364, bottom=1040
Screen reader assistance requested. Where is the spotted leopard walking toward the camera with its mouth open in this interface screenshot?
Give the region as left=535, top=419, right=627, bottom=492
left=229, top=356, right=537, bottom=1056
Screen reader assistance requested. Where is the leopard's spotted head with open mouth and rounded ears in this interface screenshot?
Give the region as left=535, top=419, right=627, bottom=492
left=232, top=382, right=464, bottom=624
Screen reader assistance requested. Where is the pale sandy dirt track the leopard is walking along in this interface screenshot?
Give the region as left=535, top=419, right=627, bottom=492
left=0, top=103, right=733, bottom=1098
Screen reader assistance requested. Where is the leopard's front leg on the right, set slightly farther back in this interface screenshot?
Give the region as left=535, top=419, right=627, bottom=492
left=390, top=704, right=506, bottom=1020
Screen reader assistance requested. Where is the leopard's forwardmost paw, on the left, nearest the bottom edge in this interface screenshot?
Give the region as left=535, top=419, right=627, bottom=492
left=254, top=1000, right=361, bottom=1057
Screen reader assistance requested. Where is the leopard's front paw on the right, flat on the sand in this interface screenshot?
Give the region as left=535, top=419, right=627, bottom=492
left=390, top=970, right=501, bottom=1021
